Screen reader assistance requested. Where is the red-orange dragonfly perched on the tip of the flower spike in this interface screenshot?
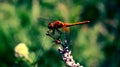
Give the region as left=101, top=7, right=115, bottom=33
left=39, top=18, right=90, bottom=34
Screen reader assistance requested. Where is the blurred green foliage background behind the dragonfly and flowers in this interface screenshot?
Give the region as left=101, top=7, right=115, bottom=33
left=0, top=0, right=120, bottom=67
